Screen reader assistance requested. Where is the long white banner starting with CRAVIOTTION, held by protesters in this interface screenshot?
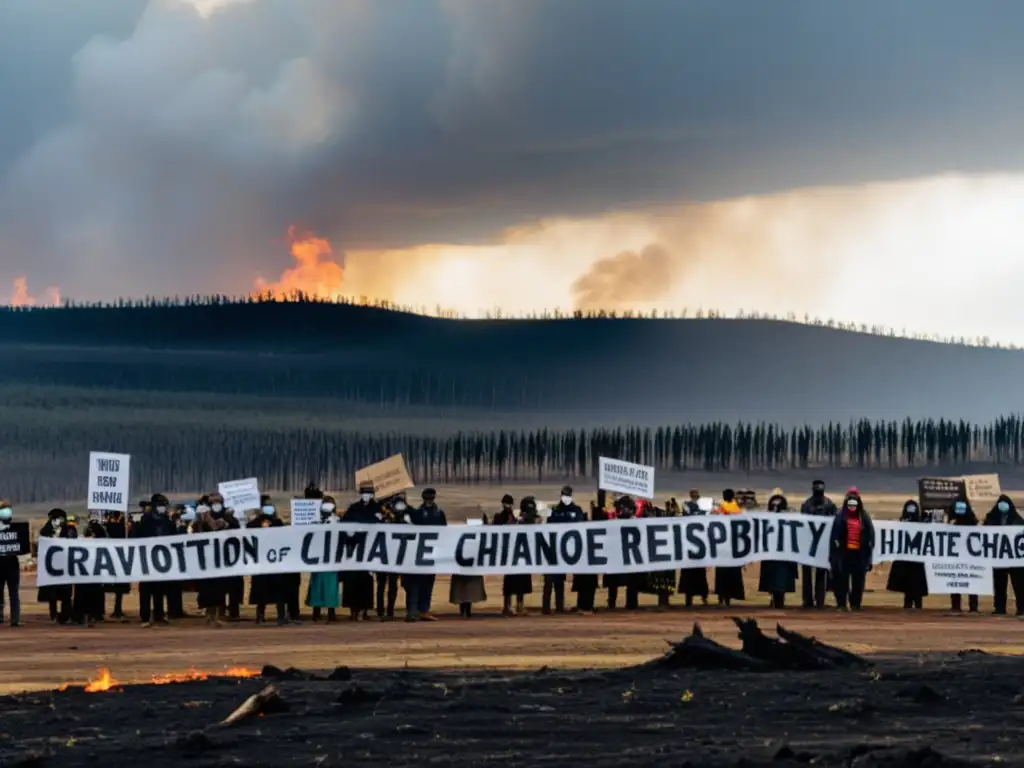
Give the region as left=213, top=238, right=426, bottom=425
left=37, top=513, right=831, bottom=587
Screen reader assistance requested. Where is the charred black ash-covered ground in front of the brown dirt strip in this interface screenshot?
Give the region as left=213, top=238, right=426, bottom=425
left=0, top=651, right=1024, bottom=768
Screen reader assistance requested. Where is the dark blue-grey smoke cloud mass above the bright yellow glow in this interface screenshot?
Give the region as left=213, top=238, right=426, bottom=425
left=0, top=0, right=1024, bottom=296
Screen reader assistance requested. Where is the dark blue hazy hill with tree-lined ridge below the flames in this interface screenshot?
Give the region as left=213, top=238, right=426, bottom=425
left=0, top=302, right=1024, bottom=424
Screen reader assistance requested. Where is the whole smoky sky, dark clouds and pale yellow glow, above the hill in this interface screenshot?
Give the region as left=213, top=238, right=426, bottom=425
left=0, top=0, right=1024, bottom=334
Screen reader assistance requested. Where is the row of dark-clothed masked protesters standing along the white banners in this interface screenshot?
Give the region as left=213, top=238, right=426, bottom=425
left=0, top=480, right=1024, bottom=627
